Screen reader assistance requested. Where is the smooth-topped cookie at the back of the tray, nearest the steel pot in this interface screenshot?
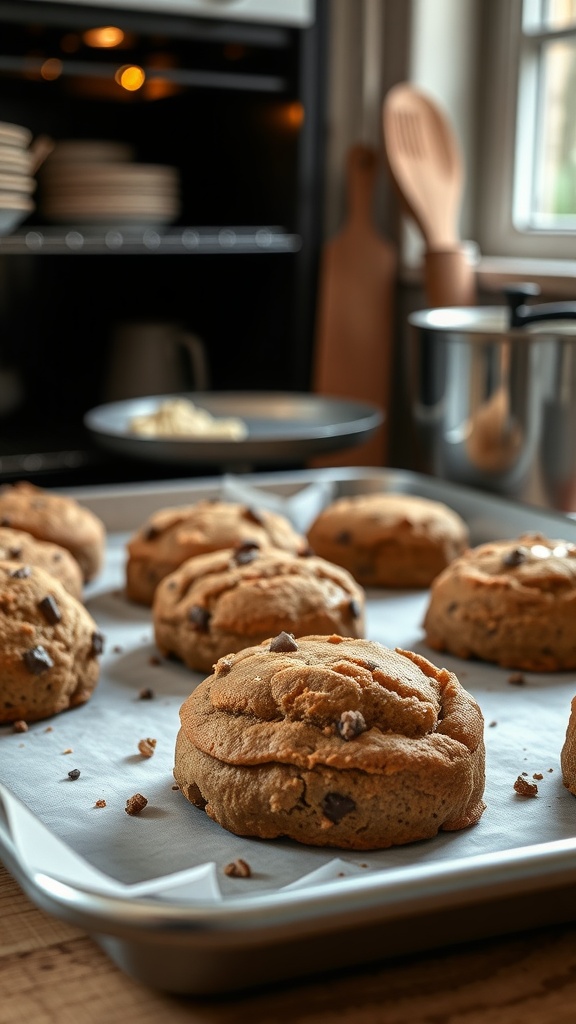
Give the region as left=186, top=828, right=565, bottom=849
left=307, top=494, right=469, bottom=589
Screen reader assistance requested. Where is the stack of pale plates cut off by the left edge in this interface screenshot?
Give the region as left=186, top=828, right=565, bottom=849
left=0, top=121, right=36, bottom=236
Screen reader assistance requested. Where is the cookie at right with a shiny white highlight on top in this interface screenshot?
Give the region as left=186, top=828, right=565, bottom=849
left=423, top=532, right=576, bottom=672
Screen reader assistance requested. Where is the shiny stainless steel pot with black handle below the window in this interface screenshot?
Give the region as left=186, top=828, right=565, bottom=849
left=408, top=286, right=576, bottom=512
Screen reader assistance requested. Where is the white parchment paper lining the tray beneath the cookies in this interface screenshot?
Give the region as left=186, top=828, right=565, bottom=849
left=0, top=473, right=576, bottom=902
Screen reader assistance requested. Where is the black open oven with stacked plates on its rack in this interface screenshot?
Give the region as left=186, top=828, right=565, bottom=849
left=0, top=0, right=328, bottom=486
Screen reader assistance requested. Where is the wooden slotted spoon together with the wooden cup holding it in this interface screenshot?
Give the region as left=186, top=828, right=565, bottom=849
left=382, top=82, right=476, bottom=306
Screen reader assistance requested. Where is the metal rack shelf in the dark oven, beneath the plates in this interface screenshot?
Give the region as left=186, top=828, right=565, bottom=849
left=0, top=226, right=302, bottom=256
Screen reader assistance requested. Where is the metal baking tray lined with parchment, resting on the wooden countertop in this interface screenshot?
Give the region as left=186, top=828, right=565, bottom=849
left=0, top=467, right=576, bottom=994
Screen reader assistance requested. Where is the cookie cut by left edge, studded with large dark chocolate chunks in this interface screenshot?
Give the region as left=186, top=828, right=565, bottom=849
left=0, top=560, right=104, bottom=723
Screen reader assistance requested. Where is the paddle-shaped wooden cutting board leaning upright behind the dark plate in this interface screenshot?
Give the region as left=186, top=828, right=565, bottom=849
left=312, top=143, right=397, bottom=466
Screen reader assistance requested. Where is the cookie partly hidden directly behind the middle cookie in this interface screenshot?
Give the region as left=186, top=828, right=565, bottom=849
left=125, top=499, right=308, bottom=605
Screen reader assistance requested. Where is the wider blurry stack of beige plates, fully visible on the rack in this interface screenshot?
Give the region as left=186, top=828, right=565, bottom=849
left=40, top=139, right=180, bottom=229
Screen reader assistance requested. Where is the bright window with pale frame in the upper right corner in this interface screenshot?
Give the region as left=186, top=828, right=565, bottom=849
left=477, top=0, right=576, bottom=259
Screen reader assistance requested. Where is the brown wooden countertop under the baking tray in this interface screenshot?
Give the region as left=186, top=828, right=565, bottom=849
left=0, top=865, right=576, bottom=1024
